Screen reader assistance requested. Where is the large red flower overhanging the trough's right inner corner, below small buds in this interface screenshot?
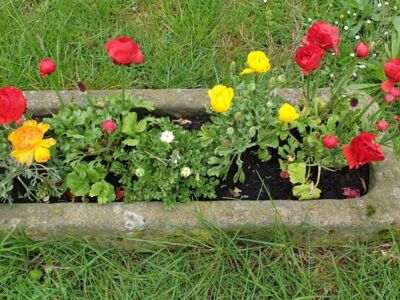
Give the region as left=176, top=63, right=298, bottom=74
left=342, top=132, right=385, bottom=169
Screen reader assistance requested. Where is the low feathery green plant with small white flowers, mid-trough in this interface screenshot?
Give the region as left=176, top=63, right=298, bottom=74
left=111, top=118, right=218, bottom=209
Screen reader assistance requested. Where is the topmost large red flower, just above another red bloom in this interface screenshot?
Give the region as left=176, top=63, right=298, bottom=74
left=304, top=21, right=340, bottom=54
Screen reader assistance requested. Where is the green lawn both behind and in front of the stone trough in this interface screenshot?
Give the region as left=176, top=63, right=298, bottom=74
left=0, top=0, right=400, bottom=299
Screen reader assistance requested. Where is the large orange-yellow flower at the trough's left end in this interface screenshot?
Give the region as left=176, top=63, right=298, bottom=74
left=8, top=120, right=56, bottom=165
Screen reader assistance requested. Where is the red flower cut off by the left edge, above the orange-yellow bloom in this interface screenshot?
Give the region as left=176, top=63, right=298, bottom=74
left=0, top=86, right=26, bottom=124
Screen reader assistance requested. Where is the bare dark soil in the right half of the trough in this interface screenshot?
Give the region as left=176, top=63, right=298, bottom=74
left=217, top=150, right=369, bottom=200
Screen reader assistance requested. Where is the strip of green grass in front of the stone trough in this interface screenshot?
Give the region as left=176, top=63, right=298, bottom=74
left=0, top=231, right=400, bottom=299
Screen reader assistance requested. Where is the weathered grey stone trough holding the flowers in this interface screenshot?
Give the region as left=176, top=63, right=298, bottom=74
left=0, top=90, right=400, bottom=248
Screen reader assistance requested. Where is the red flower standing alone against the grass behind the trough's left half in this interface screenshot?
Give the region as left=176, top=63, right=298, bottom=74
left=105, top=36, right=144, bottom=66
